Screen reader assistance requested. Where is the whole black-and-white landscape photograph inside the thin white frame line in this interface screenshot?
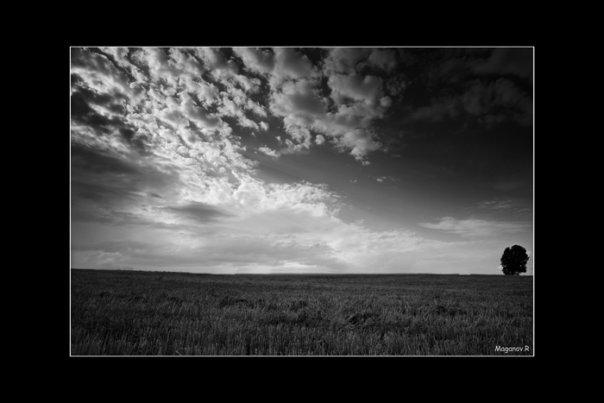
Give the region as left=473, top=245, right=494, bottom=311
left=65, top=44, right=535, bottom=359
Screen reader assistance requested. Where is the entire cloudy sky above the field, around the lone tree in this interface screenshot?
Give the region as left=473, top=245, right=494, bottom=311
left=70, top=47, right=534, bottom=274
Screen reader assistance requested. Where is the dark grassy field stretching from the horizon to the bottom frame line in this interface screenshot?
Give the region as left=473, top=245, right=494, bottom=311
left=71, top=269, right=533, bottom=355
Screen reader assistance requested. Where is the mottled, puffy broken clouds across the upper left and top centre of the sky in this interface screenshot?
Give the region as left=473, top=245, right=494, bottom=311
left=72, top=48, right=406, bottom=181
